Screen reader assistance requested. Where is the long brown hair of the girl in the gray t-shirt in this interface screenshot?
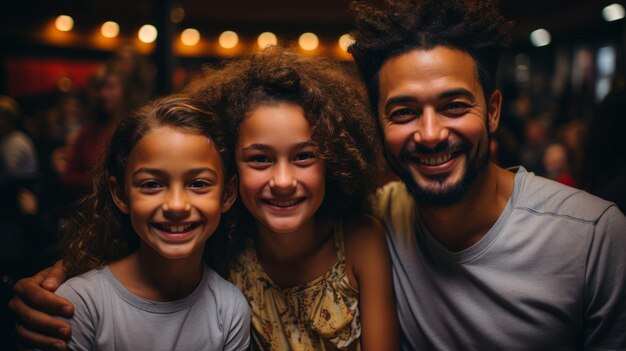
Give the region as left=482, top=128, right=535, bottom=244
left=61, top=94, right=234, bottom=276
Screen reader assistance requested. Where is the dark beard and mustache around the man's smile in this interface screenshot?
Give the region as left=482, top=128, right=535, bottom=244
left=394, top=133, right=491, bottom=208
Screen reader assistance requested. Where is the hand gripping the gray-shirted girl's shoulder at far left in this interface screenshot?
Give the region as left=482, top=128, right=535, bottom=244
left=9, top=261, right=74, bottom=350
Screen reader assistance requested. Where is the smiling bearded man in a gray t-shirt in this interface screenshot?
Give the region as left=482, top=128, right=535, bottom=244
left=350, top=0, right=626, bottom=350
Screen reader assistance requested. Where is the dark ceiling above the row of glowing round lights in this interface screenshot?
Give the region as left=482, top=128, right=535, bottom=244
left=0, top=0, right=623, bottom=51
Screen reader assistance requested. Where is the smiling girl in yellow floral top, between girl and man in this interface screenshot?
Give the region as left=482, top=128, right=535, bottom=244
left=191, top=48, right=398, bottom=350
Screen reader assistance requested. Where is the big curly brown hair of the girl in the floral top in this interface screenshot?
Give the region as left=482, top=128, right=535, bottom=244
left=189, top=47, right=382, bottom=248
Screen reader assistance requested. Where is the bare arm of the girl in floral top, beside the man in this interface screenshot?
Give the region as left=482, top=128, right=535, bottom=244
left=344, top=216, right=399, bottom=351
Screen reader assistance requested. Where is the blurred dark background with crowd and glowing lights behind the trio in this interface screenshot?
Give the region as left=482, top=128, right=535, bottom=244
left=0, top=0, right=626, bottom=342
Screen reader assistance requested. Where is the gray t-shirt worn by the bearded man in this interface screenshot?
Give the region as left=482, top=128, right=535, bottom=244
left=376, top=168, right=626, bottom=350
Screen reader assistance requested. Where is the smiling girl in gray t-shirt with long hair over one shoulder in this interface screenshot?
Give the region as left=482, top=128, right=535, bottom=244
left=57, top=96, right=250, bottom=350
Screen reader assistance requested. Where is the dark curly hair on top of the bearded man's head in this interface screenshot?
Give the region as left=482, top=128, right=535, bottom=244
left=348, top=0, right=511, bottom=109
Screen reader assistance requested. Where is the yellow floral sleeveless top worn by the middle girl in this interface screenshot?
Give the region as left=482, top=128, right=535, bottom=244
left=229, top=223, right=361, bottom=351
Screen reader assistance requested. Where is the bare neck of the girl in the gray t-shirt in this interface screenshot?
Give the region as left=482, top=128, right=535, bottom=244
left=109, top=243, right=204, bottom=301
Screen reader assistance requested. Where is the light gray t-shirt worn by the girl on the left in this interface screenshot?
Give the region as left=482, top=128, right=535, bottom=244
left=57, top=265, right=250, bottom=351
